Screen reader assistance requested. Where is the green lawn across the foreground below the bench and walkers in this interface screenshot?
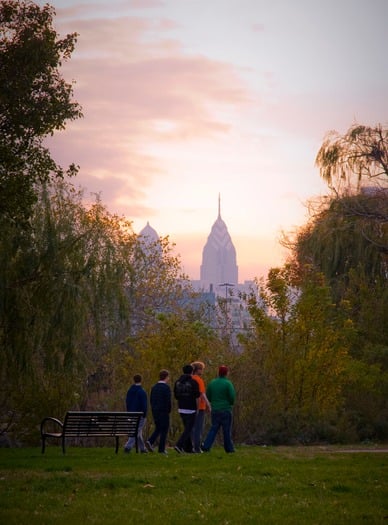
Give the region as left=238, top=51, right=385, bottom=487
left=0, top=446, right=388, bottom=525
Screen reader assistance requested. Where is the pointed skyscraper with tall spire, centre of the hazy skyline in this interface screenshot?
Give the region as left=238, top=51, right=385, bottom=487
left=200, top=195, right=238, bottom=293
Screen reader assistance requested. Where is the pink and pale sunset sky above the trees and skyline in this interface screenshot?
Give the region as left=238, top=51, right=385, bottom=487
left=36, top=0, right=388, bottom=282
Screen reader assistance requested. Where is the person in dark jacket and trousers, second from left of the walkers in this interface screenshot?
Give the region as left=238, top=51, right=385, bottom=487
left=145, top=370, right=171, bottom=454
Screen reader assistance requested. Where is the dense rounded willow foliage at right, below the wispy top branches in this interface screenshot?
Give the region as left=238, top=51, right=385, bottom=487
left=292, top=191, right=388, bottom=300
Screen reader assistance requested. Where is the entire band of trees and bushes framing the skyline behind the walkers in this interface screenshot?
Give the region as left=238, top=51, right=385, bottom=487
left=0, top=0, right=388, bottom=444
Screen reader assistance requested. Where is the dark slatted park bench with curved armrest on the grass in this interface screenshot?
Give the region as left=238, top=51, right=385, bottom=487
left=40, top=412, right=143, bottom=454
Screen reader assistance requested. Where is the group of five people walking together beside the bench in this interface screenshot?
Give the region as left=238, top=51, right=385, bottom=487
left=124, top=361, right=236, bottom=455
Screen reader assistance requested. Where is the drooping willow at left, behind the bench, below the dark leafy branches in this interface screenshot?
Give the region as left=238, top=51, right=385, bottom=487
left=0, top=182, right=140, bottom=438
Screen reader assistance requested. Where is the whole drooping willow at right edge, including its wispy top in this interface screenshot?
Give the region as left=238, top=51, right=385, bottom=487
left=289, top=125, right=388, bottom=312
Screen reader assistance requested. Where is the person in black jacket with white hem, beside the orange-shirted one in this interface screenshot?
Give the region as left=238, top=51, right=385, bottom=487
left=174, top=365, right=200, bottom=454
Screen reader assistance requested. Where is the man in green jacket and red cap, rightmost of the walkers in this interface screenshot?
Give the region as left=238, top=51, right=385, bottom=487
left=202, top=365, right=236, bottom=453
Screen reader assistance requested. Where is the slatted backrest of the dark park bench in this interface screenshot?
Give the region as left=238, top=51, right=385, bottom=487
left=63, top=412, right=143, bottom=437
